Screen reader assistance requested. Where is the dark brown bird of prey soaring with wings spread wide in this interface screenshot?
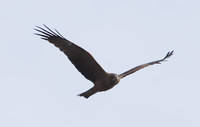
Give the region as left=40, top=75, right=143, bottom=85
left=34, top=24, right=174, bottom=98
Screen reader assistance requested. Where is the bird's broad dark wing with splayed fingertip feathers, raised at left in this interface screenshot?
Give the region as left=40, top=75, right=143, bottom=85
left=35, top=25, right=106, bottom=83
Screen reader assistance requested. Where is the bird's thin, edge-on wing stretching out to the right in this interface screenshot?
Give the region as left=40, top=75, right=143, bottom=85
left=119, top=51, right=174, bottom=78
